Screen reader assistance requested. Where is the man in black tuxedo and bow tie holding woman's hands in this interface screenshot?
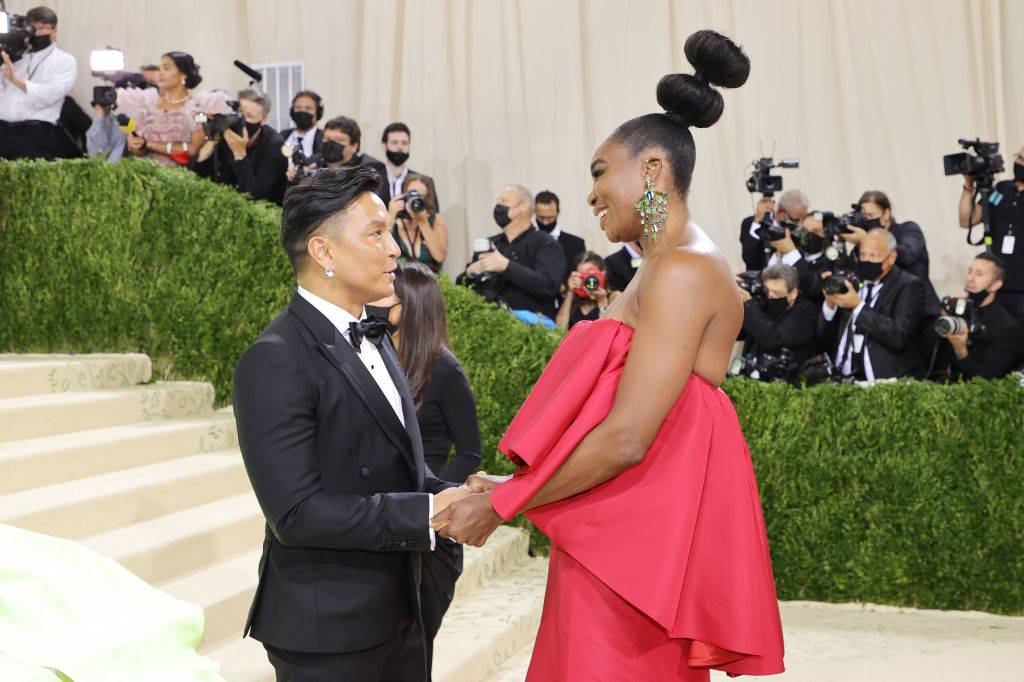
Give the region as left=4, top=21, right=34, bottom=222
left=233, top=166, right=468, bottom=682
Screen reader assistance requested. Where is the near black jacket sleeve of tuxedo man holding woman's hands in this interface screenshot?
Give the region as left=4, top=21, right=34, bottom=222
left=233, top=342, right=430, bottom=552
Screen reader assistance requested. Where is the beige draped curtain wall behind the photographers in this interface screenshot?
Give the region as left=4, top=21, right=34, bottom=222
left=9, top=0, right=1024, bottom=293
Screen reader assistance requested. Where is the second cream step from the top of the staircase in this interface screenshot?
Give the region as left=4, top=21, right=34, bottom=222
left=0, top=382, right=213, bottom=442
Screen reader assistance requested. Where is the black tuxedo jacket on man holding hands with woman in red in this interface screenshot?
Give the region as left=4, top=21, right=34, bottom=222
left=233, top=294, right=452, bottom=653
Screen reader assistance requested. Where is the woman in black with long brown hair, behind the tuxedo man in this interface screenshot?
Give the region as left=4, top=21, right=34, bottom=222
left=388, top=262, right=480, bottom=675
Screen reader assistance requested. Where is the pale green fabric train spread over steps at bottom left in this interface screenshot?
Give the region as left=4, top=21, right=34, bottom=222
left=0, top=524, right=223, bottom=682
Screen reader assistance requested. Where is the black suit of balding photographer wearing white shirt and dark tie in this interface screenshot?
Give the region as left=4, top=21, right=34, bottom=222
left=817, top=267, right=927, bottom=379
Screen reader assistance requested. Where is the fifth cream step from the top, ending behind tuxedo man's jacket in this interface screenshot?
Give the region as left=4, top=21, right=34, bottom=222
left=82, top=492, right=265, bottom=584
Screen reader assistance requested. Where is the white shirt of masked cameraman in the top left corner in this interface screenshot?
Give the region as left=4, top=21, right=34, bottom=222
left=0, top=45, right=78, bottom=123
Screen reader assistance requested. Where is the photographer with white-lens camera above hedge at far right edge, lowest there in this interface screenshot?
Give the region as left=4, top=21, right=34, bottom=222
left=934, top=252, right=1024, bottom=381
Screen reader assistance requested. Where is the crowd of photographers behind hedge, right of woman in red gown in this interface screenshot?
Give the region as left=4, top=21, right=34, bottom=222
left=730, top=140, right=1024, bottom=385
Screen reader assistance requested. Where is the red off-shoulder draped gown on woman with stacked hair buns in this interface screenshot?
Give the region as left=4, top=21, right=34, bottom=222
left=493, top=319, right=783, bottom=682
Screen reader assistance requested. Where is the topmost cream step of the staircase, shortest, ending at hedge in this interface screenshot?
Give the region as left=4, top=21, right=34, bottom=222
left=0, top=353, right=153, bottom=398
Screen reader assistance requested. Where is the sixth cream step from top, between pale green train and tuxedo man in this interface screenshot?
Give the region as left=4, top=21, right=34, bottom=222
left=159, top=549, right=261, bottom=649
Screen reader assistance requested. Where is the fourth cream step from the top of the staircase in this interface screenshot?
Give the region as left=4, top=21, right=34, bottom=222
left=0, top=451, right=251, bottom=540
